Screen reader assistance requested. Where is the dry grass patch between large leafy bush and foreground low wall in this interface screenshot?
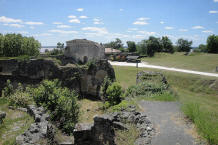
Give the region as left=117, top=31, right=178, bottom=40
left=78, top=99, right=103, bottom=123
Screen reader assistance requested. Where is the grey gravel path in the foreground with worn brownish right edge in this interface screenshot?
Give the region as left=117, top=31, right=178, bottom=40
left=139, top=100, right=202, bottom=145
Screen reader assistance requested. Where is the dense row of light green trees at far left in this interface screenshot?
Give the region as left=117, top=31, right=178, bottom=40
left=0, top=33, right=41, bottom=57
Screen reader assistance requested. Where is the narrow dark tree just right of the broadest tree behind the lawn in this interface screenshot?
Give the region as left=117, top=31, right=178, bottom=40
left=161, top=36, right=174, bottom=53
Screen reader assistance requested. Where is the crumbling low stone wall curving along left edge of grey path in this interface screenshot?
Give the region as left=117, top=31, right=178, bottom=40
left=73, top=107, right=154, bottom=145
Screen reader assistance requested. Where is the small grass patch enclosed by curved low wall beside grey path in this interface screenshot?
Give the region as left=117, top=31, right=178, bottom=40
left=115, top=124, right=139, bottom=145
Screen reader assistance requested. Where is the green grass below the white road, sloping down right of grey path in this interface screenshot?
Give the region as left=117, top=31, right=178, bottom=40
left=113, top=66, right=218, bottom=145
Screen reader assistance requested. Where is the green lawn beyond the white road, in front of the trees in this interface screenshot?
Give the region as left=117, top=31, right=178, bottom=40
left=142, top=52, right=218, bottom=73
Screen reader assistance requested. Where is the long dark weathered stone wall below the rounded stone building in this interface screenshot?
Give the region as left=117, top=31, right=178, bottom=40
left=0, top=56, right=115, bottom=97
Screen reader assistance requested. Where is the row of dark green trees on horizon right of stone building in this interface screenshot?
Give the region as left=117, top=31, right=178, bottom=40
left=103, top=35, right=218, bottom=56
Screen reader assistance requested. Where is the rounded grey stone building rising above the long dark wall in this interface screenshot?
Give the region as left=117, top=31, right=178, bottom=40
left=64, top=39, right=105, bottom=63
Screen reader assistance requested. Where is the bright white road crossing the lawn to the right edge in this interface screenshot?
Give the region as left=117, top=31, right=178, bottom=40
left=109, top=61, right=218, bottom=77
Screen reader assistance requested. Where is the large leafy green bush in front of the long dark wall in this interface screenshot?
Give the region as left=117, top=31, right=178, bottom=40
left=32, top=80, right=79, bottom=134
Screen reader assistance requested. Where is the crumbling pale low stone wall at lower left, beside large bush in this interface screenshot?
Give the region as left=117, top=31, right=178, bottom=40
left=16, top=105, right=54, bottom=145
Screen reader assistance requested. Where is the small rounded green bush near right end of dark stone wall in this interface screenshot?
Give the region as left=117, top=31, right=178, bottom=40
left=106, top=82, right=123, bottom=106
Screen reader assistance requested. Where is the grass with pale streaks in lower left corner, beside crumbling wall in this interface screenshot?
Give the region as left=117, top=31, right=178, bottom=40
left=0, top=98, right=33, bottom=145
